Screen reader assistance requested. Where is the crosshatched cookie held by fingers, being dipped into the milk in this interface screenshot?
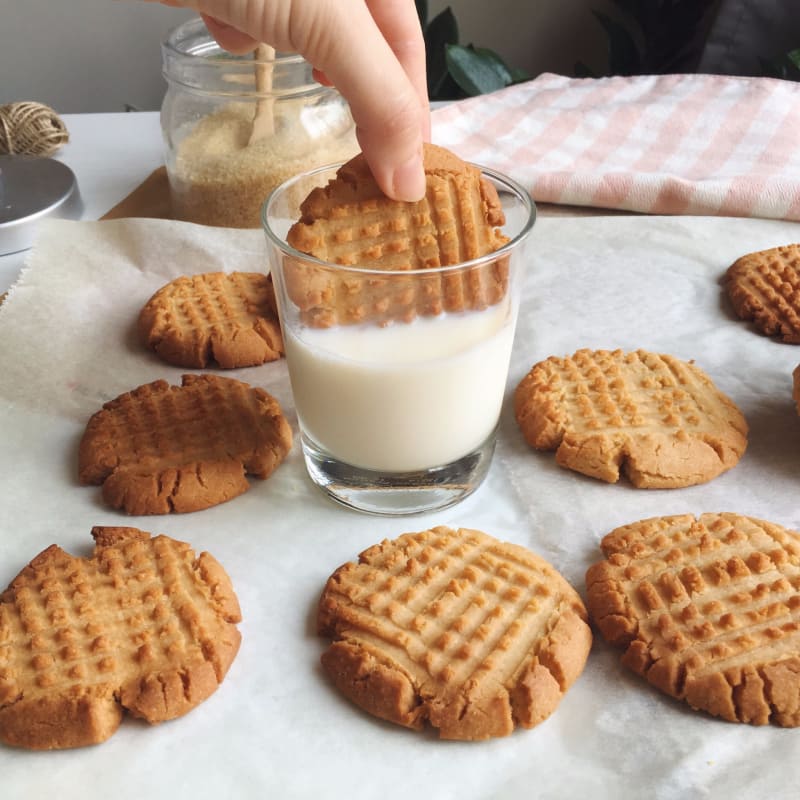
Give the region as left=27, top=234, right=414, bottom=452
left=285, top=145, right=508, bottom=327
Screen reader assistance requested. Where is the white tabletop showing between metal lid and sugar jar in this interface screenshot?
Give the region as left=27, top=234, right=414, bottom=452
left=0, top=111, right=164, bottom=293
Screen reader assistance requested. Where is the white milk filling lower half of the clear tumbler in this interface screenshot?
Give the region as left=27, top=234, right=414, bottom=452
left=285, top=298, right=515, bottom=472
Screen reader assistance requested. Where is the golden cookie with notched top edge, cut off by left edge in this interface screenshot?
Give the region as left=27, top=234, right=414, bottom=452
left=0, top=527, right=241, bottom=750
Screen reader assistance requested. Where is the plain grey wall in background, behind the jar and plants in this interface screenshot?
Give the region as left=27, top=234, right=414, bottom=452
left=0, top=0, right=609, bottom=113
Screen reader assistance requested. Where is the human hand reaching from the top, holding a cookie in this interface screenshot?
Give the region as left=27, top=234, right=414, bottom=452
left=147, top=0, right=430, bottom=200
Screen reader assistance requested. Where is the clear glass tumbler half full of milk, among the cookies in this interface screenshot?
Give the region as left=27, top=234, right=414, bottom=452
left=262, top=165, right=536, bottom=515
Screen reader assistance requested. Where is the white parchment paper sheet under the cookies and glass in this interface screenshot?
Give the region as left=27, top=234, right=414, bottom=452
left=0, top=217, right=800, bottom=800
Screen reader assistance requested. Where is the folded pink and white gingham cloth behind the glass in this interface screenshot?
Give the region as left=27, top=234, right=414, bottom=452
left=433, top=73, right=800, bottom=220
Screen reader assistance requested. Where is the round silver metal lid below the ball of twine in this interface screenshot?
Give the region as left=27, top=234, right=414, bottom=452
left=0, top=155, right=83, bottom=256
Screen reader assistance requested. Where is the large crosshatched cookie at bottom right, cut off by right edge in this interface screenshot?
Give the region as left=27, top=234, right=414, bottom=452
left=586, top=514, right=800, bottom=727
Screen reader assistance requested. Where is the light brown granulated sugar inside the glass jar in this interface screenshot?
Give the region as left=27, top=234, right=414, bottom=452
left=169, top=98, right=358, bottom=228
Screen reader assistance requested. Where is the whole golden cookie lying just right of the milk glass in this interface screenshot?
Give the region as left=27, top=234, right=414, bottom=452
left=514, top=350, right=747, bottom=489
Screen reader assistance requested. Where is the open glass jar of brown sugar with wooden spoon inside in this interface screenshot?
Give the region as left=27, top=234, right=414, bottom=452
left=161, top=17, right=358, bottom=228
